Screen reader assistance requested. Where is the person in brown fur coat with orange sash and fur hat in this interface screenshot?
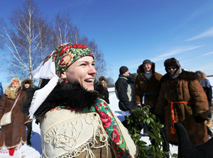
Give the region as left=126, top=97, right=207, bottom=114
left=155, top=58, right=209, bottom=145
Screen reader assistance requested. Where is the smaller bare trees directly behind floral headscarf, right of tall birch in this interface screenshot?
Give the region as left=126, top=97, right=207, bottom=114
left=51, top=14, right=106, bottom=78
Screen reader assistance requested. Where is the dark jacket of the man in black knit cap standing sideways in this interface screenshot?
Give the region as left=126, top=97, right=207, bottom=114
left=115, top=75, right=136, bottom=111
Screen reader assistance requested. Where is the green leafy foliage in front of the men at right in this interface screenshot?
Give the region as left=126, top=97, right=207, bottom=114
left=127, top=106, right=168, bottom=158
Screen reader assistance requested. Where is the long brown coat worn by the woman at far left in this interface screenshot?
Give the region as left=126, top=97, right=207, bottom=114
left=0, top=88, right=28, bottom=149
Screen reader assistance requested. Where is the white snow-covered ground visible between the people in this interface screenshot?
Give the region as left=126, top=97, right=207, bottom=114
left=0, top=88, right=213, bottom=158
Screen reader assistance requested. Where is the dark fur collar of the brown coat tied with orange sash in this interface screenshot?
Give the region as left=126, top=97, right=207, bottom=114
left=161, top=69, right=196, bottom=82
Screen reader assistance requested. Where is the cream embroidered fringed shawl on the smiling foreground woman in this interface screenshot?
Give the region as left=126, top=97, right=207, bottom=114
left=41, top=109, right=109, bottom=158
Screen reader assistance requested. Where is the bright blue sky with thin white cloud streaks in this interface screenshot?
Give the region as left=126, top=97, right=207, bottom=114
left=0, top=0, right=213, bottom=86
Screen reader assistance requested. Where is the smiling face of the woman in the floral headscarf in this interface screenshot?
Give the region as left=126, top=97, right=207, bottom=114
left=61, top=56, right=96, bottom=90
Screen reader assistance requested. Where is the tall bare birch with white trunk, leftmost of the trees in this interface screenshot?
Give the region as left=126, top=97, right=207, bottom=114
left=0, top=0, right=50, bottom=79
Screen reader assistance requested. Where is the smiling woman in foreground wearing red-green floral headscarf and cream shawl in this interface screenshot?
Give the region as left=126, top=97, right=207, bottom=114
left=23, top=43, right=136, bottom=158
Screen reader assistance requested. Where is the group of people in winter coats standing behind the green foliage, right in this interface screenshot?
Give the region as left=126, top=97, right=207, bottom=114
left=115, top=58, right=212, bottom=157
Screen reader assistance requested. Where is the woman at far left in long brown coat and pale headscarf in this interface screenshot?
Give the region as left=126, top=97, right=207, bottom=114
left=0, top=78, right=28, bottom=156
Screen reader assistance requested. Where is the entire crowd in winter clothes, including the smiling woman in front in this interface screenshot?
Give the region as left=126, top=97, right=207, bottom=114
left=0, top=43, right=212, bottom=158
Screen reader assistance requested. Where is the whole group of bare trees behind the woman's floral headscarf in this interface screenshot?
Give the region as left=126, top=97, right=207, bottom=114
left=0, top=0, right=105, bottom=79
